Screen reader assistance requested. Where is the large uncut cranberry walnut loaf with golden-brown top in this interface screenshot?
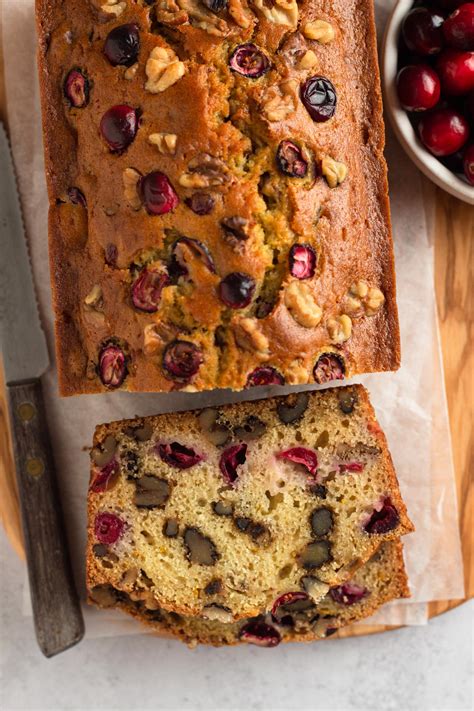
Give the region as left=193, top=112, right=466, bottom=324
left=37, top=0, right=399, bottom=395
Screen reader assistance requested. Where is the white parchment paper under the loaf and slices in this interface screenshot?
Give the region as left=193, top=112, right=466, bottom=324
left=2, top=0, right=464, bottom=637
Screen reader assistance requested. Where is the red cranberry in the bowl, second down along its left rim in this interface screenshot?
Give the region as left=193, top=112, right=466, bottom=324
left=397, top=64, right=441, bottom=111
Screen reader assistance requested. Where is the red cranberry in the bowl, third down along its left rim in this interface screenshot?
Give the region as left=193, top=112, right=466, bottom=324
left=418, top=109, right=469, bottom=156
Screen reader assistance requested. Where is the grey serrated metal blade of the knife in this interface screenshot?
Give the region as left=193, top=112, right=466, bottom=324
left=0, top=123, right=49, bottom=384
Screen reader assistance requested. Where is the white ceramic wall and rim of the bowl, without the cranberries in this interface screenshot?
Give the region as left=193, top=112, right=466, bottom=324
left=382, top=0, right=474, bottom=205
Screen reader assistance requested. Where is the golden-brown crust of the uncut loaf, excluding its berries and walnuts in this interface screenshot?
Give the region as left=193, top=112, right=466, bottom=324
left=37, top=0, right=400, bottom=395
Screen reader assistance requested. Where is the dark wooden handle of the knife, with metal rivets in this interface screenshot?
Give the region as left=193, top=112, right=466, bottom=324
left=7, top=380, right=84, bottom=657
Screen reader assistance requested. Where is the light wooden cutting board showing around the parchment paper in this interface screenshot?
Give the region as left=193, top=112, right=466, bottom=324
left=0, top=32, right=474, bottom=637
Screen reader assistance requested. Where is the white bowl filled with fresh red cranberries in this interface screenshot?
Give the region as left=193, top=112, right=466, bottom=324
left=382, top=0, right=474, bottom=205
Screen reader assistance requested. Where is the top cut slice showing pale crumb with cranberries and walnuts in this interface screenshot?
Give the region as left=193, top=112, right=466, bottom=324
left=87, top=385, right=413, bottom=620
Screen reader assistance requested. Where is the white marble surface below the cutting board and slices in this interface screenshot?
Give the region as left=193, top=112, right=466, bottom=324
left=0, top=531, right=474, bottom=711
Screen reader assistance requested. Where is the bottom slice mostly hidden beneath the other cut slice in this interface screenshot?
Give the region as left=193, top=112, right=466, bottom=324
left=89, top=541, right=410, bottom=647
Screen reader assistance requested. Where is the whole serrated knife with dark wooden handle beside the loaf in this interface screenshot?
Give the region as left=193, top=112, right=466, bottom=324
left=0, top=122, right=84, bottom=657
